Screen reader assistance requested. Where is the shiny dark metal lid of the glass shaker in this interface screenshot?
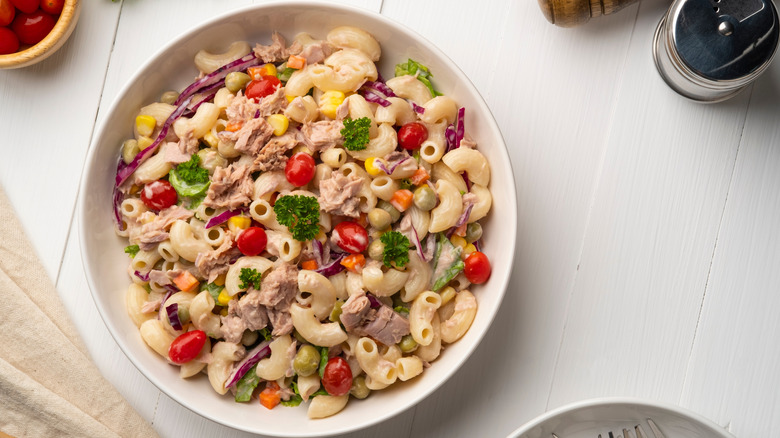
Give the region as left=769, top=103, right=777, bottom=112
left=666, top=0, right=780, bottom=81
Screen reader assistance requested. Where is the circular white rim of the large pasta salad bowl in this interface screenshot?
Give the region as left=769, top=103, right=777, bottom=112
left=78, top=0, right=517, bottom=437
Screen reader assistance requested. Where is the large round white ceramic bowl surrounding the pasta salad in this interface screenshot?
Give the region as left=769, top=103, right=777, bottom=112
left=79, top=2, right=517, bottom=436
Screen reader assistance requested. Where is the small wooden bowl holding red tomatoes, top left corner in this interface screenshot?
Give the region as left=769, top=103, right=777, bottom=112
left=0, top=0, right=81, bottom=69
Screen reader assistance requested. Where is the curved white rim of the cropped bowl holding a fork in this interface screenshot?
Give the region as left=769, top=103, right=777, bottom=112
left=507, top=396, right=734, bottom=438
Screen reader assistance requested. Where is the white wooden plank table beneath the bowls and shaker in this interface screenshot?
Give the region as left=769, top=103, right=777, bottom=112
left=0, top=0, right=780, bottom=437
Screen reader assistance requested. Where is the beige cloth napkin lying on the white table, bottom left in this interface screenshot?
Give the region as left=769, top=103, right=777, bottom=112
left=0, top=188, right=157, bottom=438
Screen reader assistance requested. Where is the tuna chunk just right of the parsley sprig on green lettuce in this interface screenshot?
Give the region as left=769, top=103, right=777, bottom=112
left=203, top=164, right=254, bottom=210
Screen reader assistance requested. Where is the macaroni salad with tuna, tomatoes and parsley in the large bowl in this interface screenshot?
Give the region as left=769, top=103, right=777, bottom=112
left=114, top=26, right=492, bottom=418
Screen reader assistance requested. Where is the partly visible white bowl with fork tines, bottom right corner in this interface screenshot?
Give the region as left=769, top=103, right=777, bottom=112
left=508, top=397, right=734, bottom=438
